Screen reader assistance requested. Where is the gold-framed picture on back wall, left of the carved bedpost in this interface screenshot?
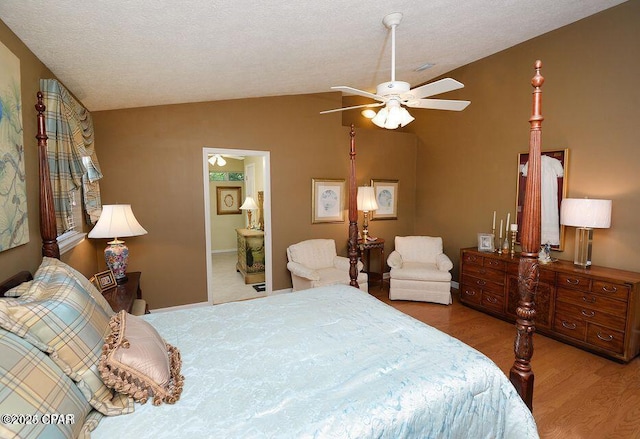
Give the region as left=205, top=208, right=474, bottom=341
left=311, top=178, right=345, bottom=224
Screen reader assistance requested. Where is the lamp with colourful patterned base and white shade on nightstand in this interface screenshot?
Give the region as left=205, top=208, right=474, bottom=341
left=89, top=204, right=147, bottom=284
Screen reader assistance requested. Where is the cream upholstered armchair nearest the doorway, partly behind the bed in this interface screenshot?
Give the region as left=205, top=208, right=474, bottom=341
left=287, top=239, right=368, bottom=291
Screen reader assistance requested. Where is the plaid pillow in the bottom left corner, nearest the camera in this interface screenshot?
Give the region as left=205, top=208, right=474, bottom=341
left=0, top=329, right=96, bottom=438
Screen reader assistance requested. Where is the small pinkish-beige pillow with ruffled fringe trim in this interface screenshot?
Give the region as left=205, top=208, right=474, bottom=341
left=98, top=311, right=184, bottom=405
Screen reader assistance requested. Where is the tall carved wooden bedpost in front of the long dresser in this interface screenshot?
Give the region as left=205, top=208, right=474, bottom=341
left=509, top=61, right=544, bottom=410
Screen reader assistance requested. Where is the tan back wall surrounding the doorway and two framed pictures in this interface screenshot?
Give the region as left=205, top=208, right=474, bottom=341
left=93, top=93, right=416, bottom=308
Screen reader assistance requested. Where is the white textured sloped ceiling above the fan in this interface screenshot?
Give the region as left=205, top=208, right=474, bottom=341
left=0, top=0, right=622, bottom=111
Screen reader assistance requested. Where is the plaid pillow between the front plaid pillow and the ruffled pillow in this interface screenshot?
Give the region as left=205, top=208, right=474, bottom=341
left=0, top=269, right=133, bottom=415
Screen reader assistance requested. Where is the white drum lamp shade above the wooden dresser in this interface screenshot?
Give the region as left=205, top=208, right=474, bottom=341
left=560, top=198, right=611, bottom=229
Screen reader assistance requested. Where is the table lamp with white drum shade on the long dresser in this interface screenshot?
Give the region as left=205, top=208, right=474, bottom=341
left=560, top=198, right=611, bottom=268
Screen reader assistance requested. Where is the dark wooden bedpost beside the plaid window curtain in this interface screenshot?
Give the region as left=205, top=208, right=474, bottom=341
left=36, top=91, right=60, bottom=259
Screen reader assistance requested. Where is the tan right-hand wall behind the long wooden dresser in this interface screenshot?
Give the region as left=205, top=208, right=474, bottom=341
left=408, top=1, right=640, bottom=276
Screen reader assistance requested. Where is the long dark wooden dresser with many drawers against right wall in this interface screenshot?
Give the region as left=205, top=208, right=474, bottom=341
left=460, top=248, right=640, bottom=362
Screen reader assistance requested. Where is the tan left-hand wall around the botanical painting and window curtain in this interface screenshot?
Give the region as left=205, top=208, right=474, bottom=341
left=0, top=21, right=97, bottom=281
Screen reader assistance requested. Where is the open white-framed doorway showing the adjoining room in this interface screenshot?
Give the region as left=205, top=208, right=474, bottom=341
left=202, top=147, right=273, bottom=304
